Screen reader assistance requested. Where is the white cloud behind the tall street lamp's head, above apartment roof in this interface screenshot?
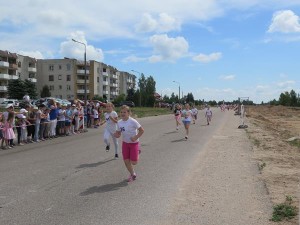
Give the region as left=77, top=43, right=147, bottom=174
left=60, top=31, right=104, bottom=62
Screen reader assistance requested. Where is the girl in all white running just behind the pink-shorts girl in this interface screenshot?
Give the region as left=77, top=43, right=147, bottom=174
left=101, top=102, right=119, bottom=159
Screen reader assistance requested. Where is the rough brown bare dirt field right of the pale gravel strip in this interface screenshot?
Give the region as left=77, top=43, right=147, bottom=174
left=246, top=106, right=300, bottom=225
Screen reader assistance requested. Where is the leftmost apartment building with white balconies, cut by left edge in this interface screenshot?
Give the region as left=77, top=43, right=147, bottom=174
left=0, top=50, right=19, bottom=99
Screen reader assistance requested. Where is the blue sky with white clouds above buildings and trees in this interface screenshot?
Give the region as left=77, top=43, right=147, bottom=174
left=0, top=0, right=300, bottom=103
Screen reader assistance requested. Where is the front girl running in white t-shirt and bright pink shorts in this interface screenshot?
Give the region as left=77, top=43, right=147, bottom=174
left=114, top=105, right=144, bottom=182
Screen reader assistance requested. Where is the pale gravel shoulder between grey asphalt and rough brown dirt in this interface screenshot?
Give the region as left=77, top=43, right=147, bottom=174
left=163, top=111, right=273, bottom=225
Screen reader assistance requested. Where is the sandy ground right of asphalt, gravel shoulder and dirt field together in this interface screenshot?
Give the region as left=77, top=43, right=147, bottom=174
left=162, top=108, right=300, bottom=225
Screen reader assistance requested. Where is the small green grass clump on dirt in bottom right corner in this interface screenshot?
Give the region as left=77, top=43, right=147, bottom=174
left=271, top=196, right=297, bottom=222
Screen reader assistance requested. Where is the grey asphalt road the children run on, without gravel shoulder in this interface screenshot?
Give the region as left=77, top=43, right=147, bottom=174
left=0, top=110, right=226, bottom=225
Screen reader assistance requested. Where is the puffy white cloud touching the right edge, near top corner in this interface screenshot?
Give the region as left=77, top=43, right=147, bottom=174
left=268, top=10, right=300, bottom=33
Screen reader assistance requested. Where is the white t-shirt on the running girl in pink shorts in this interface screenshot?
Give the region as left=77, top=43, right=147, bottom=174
left=117, top=117, right=141, bottom=143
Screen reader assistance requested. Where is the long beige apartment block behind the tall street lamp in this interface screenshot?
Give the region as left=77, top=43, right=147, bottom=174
left=37, top=58, right=135, bottom=101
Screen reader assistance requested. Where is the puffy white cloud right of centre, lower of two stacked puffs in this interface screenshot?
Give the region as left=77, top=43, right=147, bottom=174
left=149, top=34, right=189, bottom=62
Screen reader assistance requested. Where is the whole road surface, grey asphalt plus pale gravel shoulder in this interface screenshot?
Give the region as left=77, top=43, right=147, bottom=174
left=0, top=110, right=271, bottom=225
